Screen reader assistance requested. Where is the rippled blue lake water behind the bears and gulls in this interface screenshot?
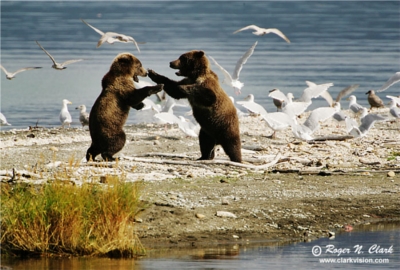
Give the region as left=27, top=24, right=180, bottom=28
left=0, top=1, right=400, bottom=130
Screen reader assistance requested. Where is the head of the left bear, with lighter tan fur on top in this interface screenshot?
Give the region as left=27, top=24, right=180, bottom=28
left=110, top=53, right=147, bottom=82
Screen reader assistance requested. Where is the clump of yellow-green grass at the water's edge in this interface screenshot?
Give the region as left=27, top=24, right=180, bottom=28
left=1, top=176, right=144, bottom=257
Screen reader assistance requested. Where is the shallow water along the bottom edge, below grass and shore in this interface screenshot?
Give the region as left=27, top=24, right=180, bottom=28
left=2, top=222, right=400, bottom=270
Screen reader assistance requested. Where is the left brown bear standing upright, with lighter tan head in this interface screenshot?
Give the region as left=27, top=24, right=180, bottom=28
left=86, top=53, right=163, bottom=161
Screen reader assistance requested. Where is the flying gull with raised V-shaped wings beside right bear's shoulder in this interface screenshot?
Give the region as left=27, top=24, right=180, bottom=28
left=209, top=41, right=257, bottom=95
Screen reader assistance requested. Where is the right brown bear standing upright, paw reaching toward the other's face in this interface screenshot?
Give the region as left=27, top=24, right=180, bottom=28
left=149, top=51, right=242, bottom=162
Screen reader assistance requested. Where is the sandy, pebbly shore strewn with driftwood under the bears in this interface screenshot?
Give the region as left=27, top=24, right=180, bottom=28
left=0, top=112, right=400, bottom=249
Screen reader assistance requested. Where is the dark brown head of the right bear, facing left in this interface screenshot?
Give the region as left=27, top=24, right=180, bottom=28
left=169, top=51, right=210, bottom=78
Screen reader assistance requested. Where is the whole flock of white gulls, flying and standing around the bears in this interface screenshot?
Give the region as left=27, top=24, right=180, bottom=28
left=0, top=19, right=400, bottom=141
